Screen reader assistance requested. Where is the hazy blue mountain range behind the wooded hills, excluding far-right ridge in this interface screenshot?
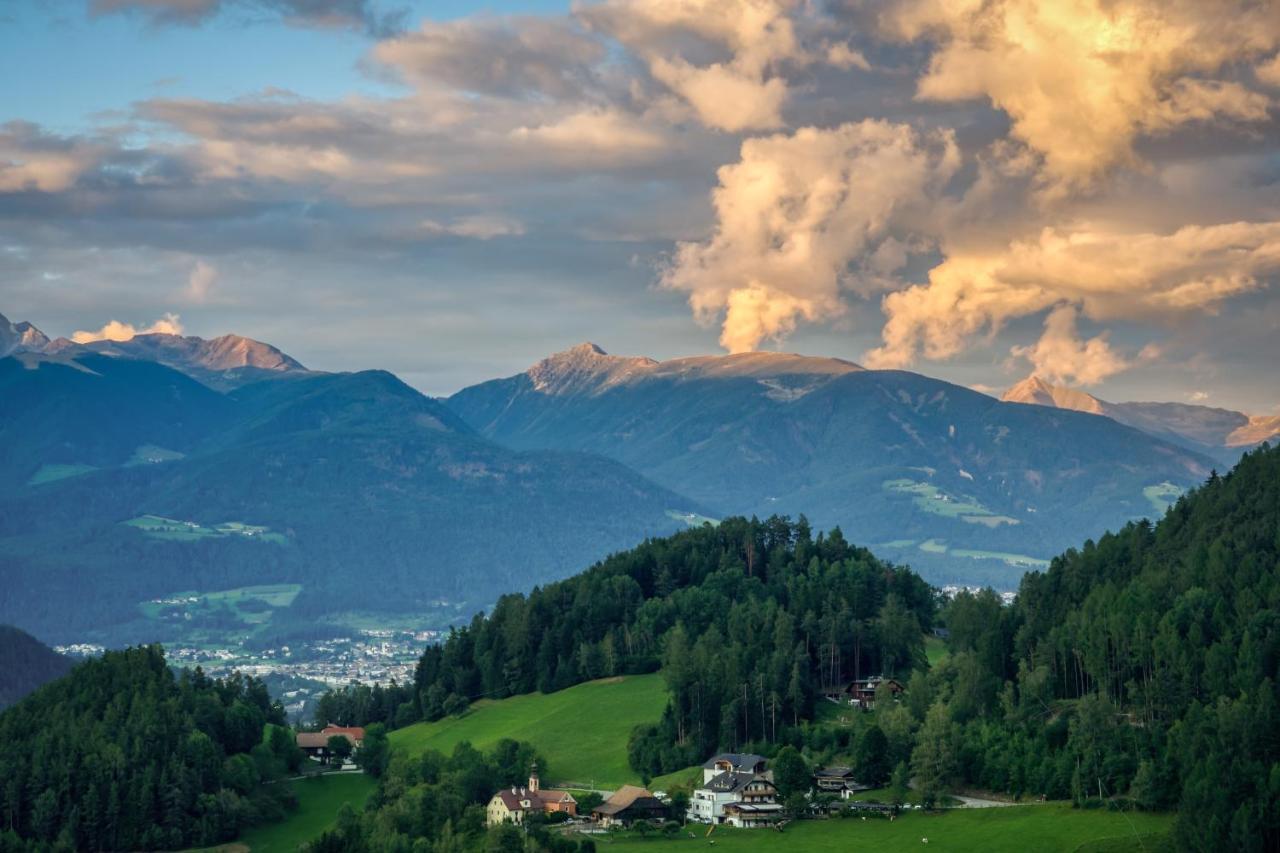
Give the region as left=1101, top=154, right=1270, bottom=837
left=0, top=312, right=1264, bottom=642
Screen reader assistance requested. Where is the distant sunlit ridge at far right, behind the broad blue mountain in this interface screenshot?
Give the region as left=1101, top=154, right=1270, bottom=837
left=1001, top=377, right=1280, bottom=464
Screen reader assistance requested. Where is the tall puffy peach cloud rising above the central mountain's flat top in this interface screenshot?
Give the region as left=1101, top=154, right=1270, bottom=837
left=662, top=122, right=957, bottom=352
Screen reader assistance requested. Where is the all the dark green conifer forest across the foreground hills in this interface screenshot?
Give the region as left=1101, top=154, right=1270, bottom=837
left=0, top=447, right=1280, bottom=850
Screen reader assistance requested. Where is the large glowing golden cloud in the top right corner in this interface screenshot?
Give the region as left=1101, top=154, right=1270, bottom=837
left=883, top=0, right=1280, bottom=195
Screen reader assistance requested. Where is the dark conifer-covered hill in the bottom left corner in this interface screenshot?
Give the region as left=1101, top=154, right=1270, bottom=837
left=0, top=646, right=303, bottom=850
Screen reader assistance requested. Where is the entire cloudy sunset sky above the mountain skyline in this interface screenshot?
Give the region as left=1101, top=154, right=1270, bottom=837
left=0, top=0, right=1280, bottom=414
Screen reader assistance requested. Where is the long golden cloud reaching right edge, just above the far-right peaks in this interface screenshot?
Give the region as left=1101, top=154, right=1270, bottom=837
left=867, top=222, right=1280, bottom=368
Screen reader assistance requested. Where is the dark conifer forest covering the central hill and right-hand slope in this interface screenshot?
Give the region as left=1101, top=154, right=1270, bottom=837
left=330, top=446, right=1280, bottom=850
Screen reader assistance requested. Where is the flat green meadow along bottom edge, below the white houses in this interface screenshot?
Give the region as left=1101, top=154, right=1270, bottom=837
left=598, top=803, right=1172, bottom=853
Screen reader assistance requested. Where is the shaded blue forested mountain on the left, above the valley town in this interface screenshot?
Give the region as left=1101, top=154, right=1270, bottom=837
left=0, top=353, right=701, bottom=643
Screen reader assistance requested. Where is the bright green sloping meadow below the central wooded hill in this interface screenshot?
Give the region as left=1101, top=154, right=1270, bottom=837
left=390, top=675, right=667, bottom=789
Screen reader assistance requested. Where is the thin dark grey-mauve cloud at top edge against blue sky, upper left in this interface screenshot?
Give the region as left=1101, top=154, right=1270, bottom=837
left=88, top=0, right=407, bottom=37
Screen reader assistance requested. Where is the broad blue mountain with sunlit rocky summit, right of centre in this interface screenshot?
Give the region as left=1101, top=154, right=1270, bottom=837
left=447, top=345, right=1213, bottom=588
